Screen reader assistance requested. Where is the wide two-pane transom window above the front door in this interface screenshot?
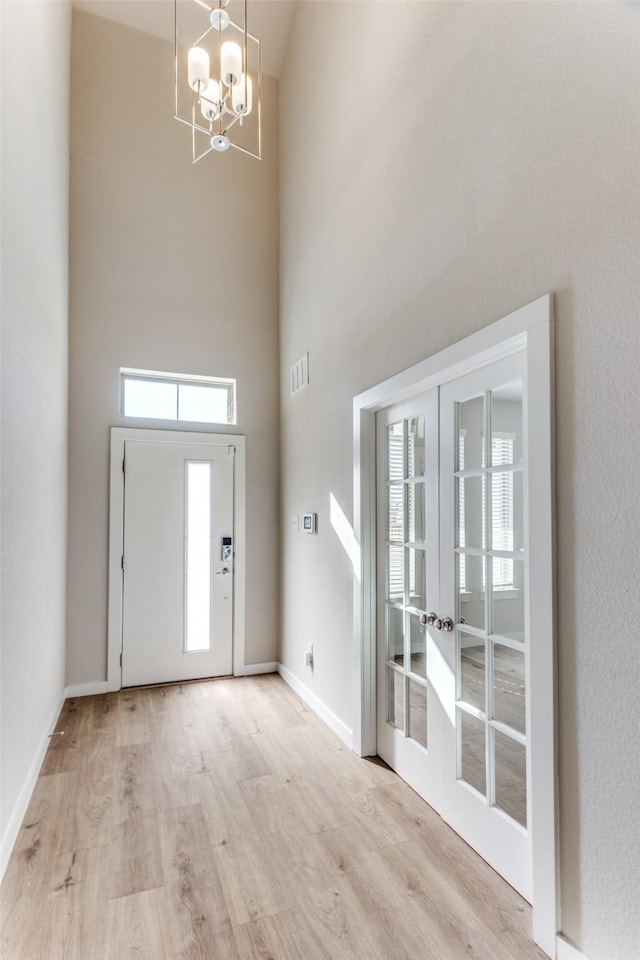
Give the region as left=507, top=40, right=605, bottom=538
left=120, top=367, right=236, bottom=423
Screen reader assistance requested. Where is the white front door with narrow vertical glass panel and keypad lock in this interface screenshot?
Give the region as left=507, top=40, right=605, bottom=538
left=122, top=440, right=235, bottom=686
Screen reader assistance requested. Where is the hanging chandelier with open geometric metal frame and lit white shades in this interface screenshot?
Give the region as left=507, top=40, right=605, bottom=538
left=174, top=0, right=262, bottom=163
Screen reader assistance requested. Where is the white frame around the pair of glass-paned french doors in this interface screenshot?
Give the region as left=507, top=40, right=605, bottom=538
left=353, top=294, right=558, bottom=957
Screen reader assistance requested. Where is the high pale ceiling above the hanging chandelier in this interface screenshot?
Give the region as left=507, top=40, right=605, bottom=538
left=73, top=0, right=294, bottom=77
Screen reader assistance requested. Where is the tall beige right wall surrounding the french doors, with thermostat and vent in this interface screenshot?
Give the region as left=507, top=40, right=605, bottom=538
left=280, top=2, right=640, bottom=960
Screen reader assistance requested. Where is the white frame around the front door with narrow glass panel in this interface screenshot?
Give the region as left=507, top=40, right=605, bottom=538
left=107, top=427, right=246, bottom=691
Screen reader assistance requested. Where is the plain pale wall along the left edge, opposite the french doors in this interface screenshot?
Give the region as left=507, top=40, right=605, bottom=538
left=0, top=0, right=71, bottom=867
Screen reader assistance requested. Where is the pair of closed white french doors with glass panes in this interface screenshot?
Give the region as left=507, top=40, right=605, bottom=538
left=377, top=354, right=532, bottom=900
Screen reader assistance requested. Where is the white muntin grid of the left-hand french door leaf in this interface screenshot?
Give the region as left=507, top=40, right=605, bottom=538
left=386, top=417, right=427, bottom=748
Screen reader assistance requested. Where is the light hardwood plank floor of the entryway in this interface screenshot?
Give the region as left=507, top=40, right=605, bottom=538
left=0, top=675, right=544, bottom=960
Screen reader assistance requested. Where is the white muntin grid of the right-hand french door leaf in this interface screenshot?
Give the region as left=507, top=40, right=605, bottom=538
left=454, top=390, right=527, bottom=832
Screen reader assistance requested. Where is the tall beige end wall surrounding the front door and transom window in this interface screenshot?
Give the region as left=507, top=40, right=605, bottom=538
left=67, top=11, right=278, bottom=685
